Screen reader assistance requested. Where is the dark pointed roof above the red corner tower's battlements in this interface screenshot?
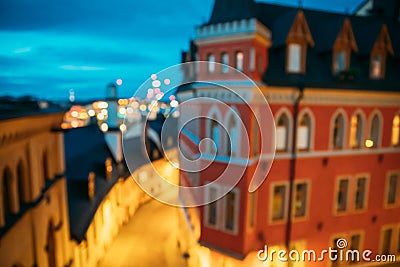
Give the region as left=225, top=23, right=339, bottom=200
left=208, top=0, right=257, bottom=25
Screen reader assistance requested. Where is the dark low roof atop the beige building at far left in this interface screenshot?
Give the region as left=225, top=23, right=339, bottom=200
left=0, top=96, right=66, bottom=120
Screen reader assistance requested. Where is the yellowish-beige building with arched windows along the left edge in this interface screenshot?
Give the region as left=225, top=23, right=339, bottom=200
left=0, top=111, right=72, bottom=267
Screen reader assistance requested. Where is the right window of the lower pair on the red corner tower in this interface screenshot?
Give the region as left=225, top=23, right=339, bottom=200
left=224, top=189, right=239, bottom=232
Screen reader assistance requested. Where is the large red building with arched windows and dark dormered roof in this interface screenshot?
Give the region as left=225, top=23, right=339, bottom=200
left=178, top=0, right=400, bottom=266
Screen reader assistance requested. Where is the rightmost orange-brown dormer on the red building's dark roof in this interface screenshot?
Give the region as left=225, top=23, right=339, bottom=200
left=370, top=25, right=393, bottom=80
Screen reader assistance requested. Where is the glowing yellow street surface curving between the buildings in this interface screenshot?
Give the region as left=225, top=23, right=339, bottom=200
left=99, top=191, right=194, bottom=267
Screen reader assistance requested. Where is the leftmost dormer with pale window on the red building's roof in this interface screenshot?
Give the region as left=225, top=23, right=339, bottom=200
left=286, top=10, right=314, bottom=73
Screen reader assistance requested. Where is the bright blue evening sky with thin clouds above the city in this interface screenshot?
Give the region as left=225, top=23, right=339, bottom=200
left=0, top=0, right=363, bottom=100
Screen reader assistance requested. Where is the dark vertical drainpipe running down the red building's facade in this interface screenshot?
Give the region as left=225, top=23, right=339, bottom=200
left=285, top=84, right=304, bottom=251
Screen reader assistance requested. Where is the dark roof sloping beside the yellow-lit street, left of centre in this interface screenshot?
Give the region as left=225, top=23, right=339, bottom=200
left=64, top=125, right=119, bottom=241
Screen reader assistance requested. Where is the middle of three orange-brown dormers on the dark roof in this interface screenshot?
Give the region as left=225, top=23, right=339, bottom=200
left=332, top=18, right=358, bottom=75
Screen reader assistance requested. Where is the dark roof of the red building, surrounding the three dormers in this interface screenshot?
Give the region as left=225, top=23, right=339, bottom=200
left=178, top=0, right=400, bottom=92
